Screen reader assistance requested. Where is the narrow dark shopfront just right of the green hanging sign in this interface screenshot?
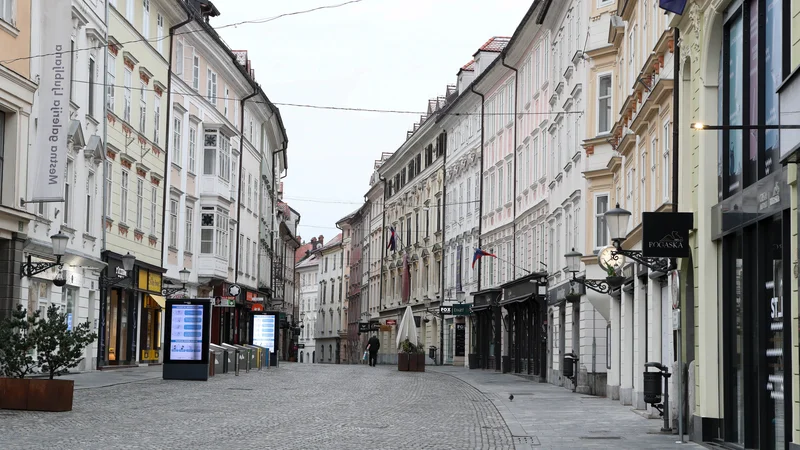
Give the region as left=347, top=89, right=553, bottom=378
left=468, top=288, right=503, bottom=370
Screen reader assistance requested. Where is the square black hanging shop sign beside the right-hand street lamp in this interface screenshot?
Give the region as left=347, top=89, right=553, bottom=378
left=642, top=212, right=694, bottom=258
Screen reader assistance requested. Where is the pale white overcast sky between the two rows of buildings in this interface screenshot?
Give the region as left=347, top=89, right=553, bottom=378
left=219, top=0, right=531, bottom=241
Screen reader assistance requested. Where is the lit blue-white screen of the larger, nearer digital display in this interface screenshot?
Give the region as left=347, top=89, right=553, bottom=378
left=169, top=304, right=204, bottom=361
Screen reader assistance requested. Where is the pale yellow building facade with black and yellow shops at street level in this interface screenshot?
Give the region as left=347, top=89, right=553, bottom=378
left=98, top=0, right=187, bottom=366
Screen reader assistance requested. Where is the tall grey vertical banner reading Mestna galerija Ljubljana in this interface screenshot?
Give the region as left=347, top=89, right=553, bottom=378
left=30, top=0, right=72, bottom=201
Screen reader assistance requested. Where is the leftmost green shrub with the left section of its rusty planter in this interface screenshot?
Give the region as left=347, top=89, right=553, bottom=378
left=0, top=305, right=39, bottom=409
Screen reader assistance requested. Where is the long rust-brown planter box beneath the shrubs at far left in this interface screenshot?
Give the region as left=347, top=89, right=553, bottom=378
left=0, top=378, right=75, bottom=412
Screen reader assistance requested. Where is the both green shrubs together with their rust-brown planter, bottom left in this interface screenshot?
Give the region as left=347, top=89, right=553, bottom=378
left=0, top=305, right=97, bottom=411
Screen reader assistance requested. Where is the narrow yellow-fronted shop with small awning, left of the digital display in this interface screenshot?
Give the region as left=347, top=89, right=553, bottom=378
left=135, top=267, right=166, bottom=364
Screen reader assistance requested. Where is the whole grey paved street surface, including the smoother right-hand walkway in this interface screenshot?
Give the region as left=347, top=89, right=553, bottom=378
left=0, top=363, right=696, bottom=450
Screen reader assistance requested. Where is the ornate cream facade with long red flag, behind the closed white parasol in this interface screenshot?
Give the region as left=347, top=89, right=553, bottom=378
left=378, top=87, right=455, bottom=364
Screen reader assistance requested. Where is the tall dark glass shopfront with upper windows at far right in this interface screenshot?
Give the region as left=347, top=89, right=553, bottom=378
left=711, top=0, right=797, bottom=449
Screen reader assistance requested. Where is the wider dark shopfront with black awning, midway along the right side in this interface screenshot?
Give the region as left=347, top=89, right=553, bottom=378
left=500, top=273, right=547, bottom=381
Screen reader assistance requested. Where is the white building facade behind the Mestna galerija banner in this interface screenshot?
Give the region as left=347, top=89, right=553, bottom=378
left=22, top=0, right=108, bottom=370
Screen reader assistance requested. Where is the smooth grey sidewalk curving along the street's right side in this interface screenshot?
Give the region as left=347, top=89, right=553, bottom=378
left=425, top=366, right=701, bottom=450
